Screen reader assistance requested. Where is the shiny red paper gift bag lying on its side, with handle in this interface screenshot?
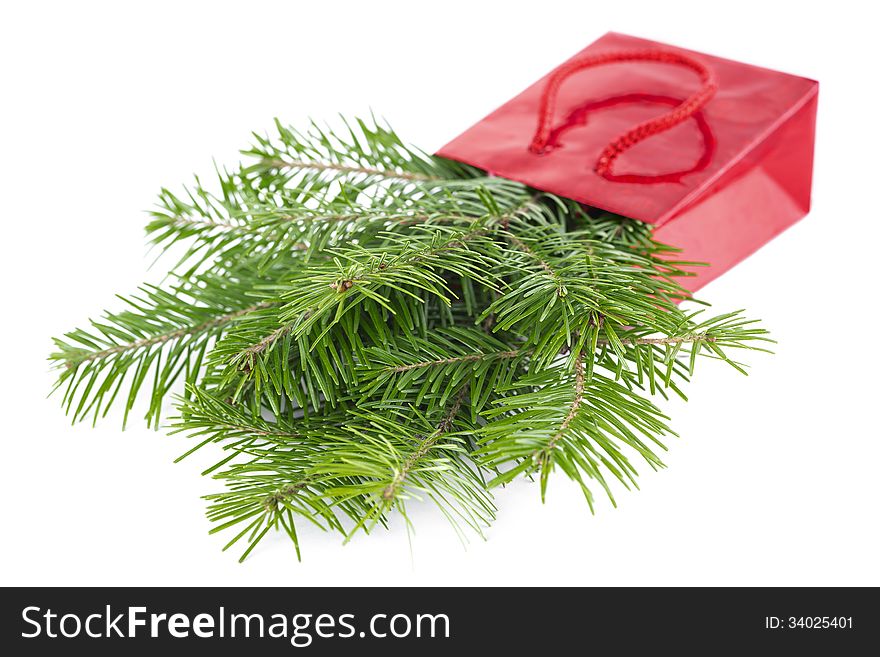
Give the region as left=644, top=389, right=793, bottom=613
left=438, top=33, right=819, bottom=290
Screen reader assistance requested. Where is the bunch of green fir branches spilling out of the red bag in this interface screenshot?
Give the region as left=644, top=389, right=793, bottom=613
left=50, top=115, right=770, bottom=558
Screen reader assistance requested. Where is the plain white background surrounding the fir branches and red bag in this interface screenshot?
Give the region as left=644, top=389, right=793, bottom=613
left=0, top=0, right=880, bottom=585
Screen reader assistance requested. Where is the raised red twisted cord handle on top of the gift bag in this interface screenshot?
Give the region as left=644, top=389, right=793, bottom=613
left=529, top=50, right=718, bottom=177
